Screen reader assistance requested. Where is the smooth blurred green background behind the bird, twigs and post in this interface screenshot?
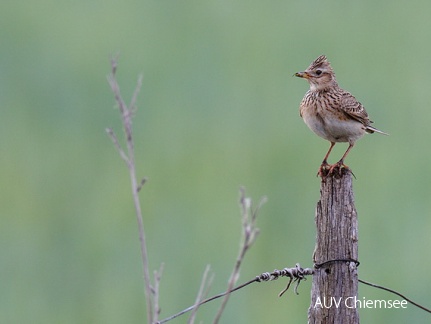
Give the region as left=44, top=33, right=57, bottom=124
left=0, top=0, right=431, bottom=323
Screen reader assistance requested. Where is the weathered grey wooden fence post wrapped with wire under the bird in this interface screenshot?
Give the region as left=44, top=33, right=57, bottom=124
left=308, top=169, right=359, bottom=324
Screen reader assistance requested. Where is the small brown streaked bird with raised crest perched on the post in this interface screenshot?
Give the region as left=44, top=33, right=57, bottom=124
left=294, top=55, right=388, bottom=179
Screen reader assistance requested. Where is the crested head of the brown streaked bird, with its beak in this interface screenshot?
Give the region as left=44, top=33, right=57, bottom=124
left=294, top=55, right=338, bottom=91
